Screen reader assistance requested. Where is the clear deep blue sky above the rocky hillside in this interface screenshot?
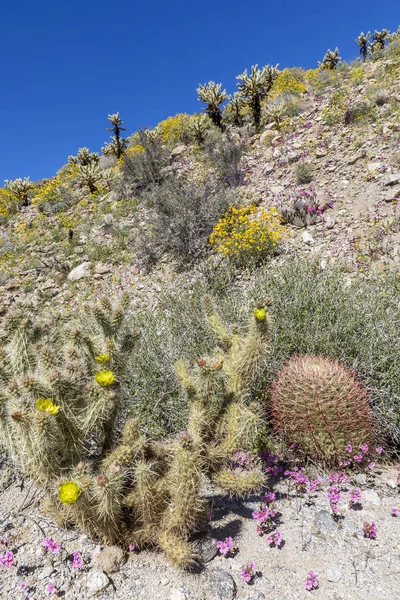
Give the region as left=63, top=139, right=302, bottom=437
left=0, top=0, right=400, bottom=186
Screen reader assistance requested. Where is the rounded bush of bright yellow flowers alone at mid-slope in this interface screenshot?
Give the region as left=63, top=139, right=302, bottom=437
left=209, top=204, right=285, bottom=263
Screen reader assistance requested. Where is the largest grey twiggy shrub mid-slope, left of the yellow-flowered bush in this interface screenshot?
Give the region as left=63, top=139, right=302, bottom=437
left=138, top=179, right=233, bottom=266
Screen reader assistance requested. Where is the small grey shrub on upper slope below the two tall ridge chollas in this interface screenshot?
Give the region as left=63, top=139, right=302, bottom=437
left=205, top=133, right=245, bottom=187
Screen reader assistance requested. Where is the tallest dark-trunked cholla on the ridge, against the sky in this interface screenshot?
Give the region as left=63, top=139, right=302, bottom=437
left=236, top=65, right=278, bottom=131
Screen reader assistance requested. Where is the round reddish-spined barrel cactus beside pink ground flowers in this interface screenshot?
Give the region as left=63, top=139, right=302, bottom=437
left=271, top=355, right=375, bottom=462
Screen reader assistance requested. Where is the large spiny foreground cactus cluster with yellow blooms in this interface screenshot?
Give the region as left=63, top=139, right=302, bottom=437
left=0, top=296, right=269, bottom=567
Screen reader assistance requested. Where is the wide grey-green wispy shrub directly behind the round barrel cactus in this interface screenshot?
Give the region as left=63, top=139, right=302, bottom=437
left=127, top=260, right=400, bottom=446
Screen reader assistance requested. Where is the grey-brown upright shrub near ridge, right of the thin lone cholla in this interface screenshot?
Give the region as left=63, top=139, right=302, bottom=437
left=119, top=131, right=170, bottom=196
